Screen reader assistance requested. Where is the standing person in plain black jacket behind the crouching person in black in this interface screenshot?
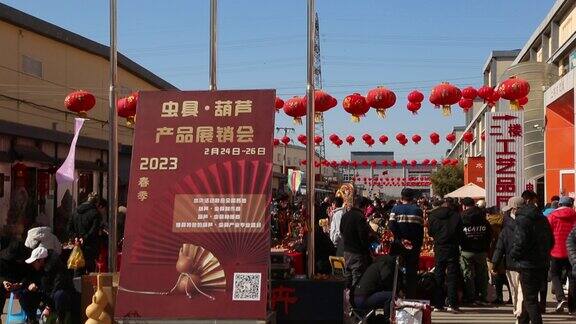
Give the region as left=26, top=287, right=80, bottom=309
left=340, top=197, right=372, bottom=288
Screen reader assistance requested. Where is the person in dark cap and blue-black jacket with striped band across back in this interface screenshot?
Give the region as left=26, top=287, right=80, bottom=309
left=388, top=188, right=424, bottom=298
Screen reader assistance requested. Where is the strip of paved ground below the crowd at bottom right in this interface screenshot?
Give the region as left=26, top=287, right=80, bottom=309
left=432, top=303, right=576, bottom=324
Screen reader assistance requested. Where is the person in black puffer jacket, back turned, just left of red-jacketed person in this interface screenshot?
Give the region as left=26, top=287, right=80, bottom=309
left=510, top=204, right=554, bottom=324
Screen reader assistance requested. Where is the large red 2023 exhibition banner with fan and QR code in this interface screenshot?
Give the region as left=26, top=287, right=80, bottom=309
left=115, top=90, right=275, bottom=319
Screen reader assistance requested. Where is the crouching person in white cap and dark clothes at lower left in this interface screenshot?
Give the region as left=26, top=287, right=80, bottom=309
left=20, top=246, right=79, bottom=323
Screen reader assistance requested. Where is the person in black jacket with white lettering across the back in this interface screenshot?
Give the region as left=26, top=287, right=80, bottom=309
left=460, top=197, right=492, bottom=305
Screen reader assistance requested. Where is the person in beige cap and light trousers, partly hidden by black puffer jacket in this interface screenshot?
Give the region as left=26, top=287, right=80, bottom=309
left=492, top=197, right=524, bottom=317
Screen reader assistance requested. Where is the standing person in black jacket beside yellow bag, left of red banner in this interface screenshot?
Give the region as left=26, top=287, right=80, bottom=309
left=68, top=193, right=106, bottom=275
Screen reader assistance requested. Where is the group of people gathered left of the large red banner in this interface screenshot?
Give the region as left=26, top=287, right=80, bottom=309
left=0, top=194, right=123, bottom=323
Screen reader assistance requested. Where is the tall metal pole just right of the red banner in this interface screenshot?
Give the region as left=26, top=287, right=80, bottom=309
left=306, top=0, right=316, bottom=278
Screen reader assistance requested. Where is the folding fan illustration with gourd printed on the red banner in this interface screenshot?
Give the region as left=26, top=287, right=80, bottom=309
left=119, top=160, right=272, bottom=300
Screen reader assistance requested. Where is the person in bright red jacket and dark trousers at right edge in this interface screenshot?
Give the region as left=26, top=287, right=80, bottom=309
left=548, top=197, right=576, bottom=312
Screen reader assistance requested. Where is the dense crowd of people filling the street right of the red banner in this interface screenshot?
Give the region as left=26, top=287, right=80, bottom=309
left=273, top=188, right=576, bottom=323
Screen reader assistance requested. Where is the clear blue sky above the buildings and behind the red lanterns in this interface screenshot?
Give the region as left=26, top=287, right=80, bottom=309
left=2, top=0, right=554, bottom=160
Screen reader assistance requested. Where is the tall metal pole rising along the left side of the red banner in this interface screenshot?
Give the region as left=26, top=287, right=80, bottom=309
left=108, top=0, right=118, bottom=272
